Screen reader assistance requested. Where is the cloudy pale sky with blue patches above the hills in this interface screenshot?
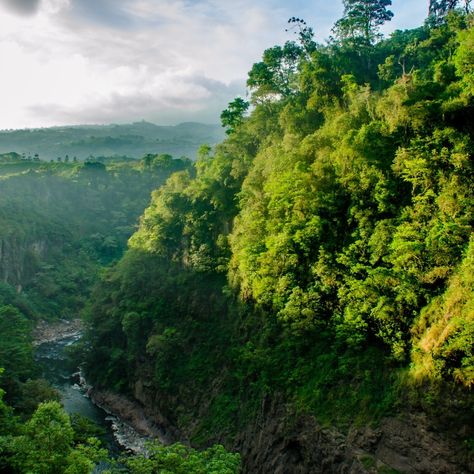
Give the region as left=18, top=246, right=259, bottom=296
left=0, top=0, right=428, bottom=129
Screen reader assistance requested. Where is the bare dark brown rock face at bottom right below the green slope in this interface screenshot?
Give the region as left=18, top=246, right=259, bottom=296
left=236, top=401, right=474, bottom=474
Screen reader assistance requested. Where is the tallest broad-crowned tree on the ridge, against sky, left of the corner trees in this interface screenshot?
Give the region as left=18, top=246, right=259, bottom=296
left=333, top=0, right=393, bottom=44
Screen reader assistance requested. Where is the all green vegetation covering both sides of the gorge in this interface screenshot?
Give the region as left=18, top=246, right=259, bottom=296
left=0, top=0, right=474, bottom=474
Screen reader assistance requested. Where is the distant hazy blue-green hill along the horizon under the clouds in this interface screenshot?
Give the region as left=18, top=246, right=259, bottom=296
left=0, top=121, right=224, bottom=160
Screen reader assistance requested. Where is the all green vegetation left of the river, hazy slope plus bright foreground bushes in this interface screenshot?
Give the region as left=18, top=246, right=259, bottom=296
left=0, top=153, right=240, bottom=474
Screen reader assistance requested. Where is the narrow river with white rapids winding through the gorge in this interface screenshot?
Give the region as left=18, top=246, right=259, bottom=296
left=35, top=332, right=147, bottom=456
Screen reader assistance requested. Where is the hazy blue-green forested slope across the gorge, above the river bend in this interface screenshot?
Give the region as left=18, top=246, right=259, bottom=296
left=0, top=155, right=189, bottom=317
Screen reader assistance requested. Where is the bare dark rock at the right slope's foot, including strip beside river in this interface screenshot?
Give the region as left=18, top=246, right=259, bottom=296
left=88, top=381, right=474, bottom=474
